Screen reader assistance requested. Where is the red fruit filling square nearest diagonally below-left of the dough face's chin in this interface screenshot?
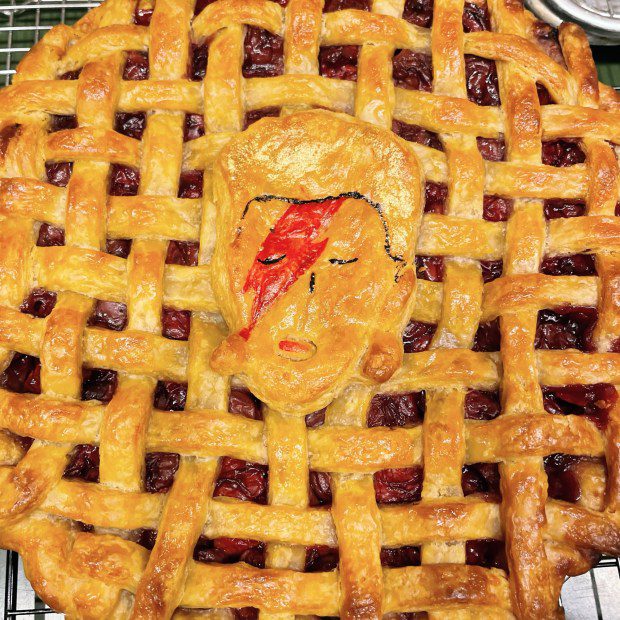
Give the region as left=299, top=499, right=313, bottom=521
left=213, top=456, right=269, bottom=504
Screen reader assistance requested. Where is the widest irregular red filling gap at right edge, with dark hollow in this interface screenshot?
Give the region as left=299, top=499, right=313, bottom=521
left=542, top=383, right=618, bottom=429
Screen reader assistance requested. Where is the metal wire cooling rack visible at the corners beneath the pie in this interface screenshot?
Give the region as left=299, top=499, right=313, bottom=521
left=0, top=0, right=620, bottom=620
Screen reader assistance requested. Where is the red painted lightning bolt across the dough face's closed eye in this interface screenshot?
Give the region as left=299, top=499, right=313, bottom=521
left=239, top=196, right=346, bottom=340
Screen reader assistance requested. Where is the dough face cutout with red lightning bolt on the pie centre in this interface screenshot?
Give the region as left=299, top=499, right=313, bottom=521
left=211, top=111, right=421, bottom=414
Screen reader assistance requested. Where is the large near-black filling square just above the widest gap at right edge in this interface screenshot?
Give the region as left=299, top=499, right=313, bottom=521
left=534, top=306, right=598, bottom=351
